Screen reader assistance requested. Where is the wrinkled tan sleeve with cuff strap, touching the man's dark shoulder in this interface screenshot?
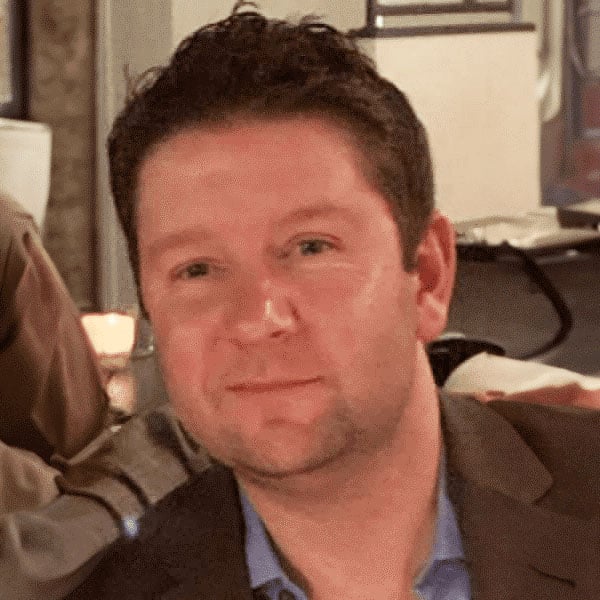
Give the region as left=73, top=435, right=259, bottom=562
left=0, top=409, right=207, bottom=600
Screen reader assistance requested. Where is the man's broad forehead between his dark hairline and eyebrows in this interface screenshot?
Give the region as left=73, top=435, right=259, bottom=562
left=138, top=117, right=396, bottom=239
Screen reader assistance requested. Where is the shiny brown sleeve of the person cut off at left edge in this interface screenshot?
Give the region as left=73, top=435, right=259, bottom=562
left=0, top=195, right=108, bottom=460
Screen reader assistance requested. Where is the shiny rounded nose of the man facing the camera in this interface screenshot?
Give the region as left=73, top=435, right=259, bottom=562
left=231, top=278, right=298, bottom=344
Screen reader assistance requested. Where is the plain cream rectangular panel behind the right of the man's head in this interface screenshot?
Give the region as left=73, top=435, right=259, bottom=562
left=363, top=32, right=541, bottom=221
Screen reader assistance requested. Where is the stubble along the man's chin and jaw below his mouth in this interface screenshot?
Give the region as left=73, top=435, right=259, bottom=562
left=173, top=380, right=408, bottom=487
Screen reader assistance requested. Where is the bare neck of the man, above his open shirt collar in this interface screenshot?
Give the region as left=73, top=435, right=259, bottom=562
left=240, top=346, right=441, bottom=599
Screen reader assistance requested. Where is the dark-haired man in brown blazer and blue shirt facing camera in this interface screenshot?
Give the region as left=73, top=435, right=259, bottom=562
left=71, top=5, right=600, bottom=600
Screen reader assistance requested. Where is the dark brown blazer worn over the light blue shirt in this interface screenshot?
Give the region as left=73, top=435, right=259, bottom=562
left=69, top=397, right=600, bottom=600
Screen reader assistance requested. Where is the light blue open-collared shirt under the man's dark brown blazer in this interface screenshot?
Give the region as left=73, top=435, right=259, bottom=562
left=240, top=460, right=471, bottom=600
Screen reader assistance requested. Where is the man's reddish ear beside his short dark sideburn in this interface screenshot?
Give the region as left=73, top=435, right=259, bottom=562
left=416, top=210, right=456, bottom=343
